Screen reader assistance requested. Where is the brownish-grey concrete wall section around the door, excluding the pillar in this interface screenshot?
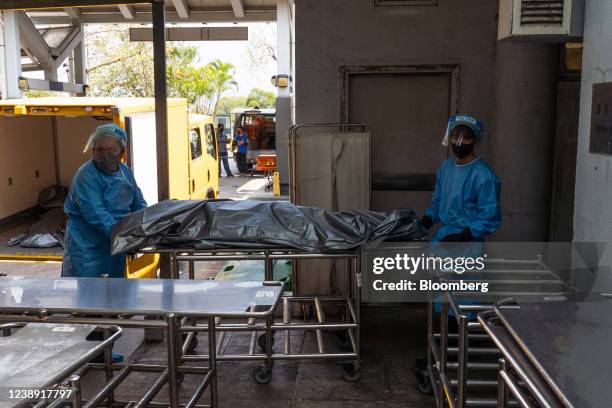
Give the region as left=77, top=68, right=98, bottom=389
left=295, top=0, right=497, bottom=158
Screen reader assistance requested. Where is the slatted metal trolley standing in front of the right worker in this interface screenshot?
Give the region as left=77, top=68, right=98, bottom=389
left=427, top=259, right=571, bottom=408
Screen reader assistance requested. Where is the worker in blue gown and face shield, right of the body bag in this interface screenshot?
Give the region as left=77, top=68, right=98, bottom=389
left=421, top=115, right=501, bottom=242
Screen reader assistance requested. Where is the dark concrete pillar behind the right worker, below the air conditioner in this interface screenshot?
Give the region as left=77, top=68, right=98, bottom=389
left=492, top=42, right=559, bottom=242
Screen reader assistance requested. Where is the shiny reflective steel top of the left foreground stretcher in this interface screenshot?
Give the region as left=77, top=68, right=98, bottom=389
left=0, top=278, right=282, bottom=317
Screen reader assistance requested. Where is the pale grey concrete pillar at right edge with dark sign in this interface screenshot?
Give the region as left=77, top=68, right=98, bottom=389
left=574, top=0, right=612, bottom=242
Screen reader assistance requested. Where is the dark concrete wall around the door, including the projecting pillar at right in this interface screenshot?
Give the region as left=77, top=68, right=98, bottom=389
left=295, top=0, right=558, bottom=241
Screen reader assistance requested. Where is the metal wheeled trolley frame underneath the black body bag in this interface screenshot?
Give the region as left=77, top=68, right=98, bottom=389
left=146, top=248, right=361, bottom=384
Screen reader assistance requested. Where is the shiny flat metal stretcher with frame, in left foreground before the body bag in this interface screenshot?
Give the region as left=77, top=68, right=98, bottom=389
left=0, top=278, right=282, bottom=408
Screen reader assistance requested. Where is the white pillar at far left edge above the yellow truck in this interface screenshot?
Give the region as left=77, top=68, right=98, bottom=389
left=0, top=11, right=22, bottom=99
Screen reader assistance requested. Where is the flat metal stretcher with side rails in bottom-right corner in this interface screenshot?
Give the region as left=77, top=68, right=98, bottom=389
left=478, top=301, right=612, bottom=408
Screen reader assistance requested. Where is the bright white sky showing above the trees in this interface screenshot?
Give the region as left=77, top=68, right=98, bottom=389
left=25, top=23, right=277, bottom=96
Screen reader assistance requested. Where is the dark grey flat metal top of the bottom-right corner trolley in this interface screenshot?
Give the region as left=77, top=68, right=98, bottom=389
left=497, top=302, right=612, bottom=408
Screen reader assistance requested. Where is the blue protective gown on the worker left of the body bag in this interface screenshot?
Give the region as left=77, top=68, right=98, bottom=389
left=62, top=160, right=147, bottom=278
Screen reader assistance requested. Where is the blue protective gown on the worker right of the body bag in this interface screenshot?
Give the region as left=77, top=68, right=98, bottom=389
left=425, top=158, right=501, bottom=242
